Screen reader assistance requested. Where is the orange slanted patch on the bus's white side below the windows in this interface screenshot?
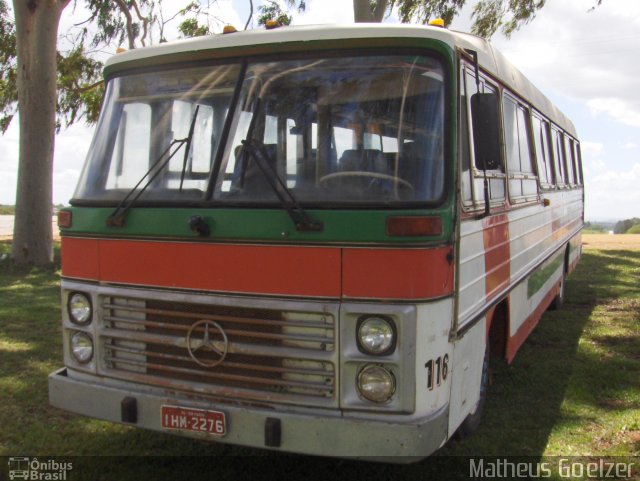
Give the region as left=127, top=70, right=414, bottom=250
left=483, top=214, right=511, bottom=300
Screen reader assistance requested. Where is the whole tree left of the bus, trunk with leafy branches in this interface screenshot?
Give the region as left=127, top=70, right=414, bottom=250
left=0, top=0, right=154, bottom=265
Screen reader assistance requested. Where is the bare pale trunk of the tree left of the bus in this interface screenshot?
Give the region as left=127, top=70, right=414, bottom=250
left=11, top=0, right=69, bottom=265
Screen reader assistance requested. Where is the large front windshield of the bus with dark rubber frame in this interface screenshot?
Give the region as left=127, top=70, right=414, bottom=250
left=74, top=55, right=445, bottom=206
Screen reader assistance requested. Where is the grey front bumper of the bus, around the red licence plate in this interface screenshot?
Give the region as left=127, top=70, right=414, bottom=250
left=49, top=368, right=448, bottom=463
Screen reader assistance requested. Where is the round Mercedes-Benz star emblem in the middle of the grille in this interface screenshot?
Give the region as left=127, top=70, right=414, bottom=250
left=187, top=320, right=229, bottom=367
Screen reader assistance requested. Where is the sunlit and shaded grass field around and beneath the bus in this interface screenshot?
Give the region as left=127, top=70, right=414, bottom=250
left=0, top=236, right=640, bottom=480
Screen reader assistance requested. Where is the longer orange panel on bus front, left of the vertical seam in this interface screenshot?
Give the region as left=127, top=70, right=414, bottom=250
left=62, top=239, right=341, bottom=297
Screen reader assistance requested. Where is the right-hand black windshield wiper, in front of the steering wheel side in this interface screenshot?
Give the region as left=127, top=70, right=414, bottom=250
left=242, top=139, right=324, bottom=232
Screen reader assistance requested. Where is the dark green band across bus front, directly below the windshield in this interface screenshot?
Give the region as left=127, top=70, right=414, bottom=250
left=61, top=207, right=453, bottom=244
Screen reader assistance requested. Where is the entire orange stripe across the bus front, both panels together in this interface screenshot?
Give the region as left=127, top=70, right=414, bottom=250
left=62, top=238, right=453, bottom=299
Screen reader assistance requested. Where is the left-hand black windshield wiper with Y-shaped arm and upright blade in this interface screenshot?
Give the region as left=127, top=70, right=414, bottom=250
left=107, top=106, right=200, bottom=227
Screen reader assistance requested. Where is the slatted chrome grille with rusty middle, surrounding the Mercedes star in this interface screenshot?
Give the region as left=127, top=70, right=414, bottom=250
left=101, top=296, right=336, bottom=405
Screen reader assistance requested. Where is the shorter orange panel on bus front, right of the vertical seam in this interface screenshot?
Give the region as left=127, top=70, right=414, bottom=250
left=342, top=246, right=453, bottom=299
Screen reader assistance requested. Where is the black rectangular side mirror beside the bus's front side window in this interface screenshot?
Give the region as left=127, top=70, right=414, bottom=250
left=471, top=93, right=501, bottom=170
